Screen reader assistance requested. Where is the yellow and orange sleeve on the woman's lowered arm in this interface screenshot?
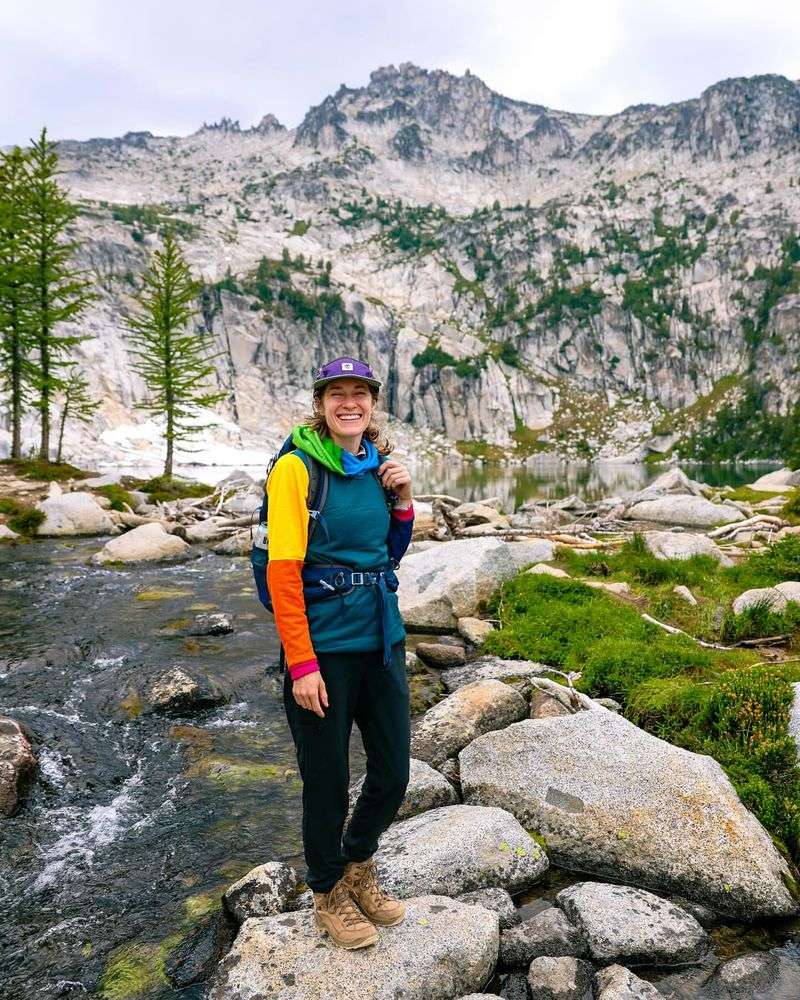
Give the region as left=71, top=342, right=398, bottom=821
left=266, top=455, right=319, bottom=680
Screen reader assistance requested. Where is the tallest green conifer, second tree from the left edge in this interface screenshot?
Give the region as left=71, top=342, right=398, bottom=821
left=25, top=128, right=95, bottom=462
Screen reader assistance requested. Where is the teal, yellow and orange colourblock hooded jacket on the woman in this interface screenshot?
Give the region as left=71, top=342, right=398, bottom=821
left=266, top=427, right=414, bottom=680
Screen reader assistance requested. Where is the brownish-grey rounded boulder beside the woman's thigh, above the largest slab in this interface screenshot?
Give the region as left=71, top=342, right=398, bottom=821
left=411, top=680, right=528, bottom=767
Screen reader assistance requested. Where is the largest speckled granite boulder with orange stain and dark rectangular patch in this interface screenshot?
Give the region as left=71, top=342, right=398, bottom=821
left=459, top=707, right=798, bottom=920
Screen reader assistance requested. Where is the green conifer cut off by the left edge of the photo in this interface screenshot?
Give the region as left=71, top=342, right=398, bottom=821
left=0, top=146, right=34, bottom=458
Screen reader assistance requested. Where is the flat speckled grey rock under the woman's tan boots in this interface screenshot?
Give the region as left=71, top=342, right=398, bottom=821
left=209, top=895, right=498, bottom=1000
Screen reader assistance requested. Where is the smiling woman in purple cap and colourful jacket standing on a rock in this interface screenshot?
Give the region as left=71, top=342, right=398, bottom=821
left=266, top=358, right=414, bottom=948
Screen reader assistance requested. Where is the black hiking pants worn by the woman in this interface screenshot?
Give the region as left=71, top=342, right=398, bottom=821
left=283, top=642, right=411, bottom=892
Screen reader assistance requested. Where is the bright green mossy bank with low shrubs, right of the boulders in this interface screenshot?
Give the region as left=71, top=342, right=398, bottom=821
left=484, top=536, right=800, bottom=860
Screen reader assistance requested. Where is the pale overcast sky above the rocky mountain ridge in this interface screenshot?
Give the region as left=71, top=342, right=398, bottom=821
left=0, top=0, right=800, bottom=145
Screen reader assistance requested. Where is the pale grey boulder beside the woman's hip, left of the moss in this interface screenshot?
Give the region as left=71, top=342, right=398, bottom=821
left=397, top=538, right=517, bottom=629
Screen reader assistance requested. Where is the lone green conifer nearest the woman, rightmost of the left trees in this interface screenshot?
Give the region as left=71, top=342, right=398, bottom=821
left=128, top=229, right=226, bottom=477
